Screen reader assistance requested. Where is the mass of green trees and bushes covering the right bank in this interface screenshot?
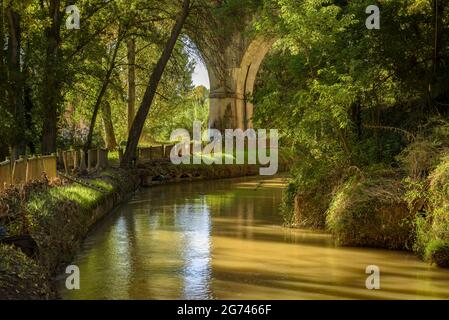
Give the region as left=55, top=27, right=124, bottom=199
left=252, top=0, right=449, bottom=251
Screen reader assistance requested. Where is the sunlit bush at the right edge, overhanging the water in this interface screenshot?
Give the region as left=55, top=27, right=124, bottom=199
left=399, top=124, right=449, bottom=267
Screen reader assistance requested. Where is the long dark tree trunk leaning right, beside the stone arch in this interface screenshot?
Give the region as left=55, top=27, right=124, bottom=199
left=120, top=0, right=190, bottom=167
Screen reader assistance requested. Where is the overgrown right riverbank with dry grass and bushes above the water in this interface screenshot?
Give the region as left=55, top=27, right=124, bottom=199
left=282, top=152, right=449, bottom=268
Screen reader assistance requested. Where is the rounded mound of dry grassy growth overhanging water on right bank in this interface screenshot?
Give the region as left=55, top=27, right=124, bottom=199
left=326, top=170, right=414, bottom=249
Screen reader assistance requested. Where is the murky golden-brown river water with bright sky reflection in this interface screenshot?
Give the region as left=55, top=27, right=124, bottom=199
left=60, top=177, right=449, bottom=299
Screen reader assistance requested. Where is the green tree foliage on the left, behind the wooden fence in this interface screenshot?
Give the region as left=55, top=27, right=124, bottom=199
left=0, top=0, right=207, bottom=156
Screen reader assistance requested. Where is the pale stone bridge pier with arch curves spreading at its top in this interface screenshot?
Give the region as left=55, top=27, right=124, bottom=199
left=188, top=7, right=275, bottom=131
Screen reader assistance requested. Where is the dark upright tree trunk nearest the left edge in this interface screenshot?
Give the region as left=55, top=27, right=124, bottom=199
left=6, top=7, right=26, bottom=160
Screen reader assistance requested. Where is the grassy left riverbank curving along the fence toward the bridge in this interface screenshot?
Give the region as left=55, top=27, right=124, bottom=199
left=0, top=163, right=258, bottom=299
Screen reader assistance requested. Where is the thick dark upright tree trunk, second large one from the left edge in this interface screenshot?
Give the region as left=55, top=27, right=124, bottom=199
left=42, top=0, right=62, bottom=154
